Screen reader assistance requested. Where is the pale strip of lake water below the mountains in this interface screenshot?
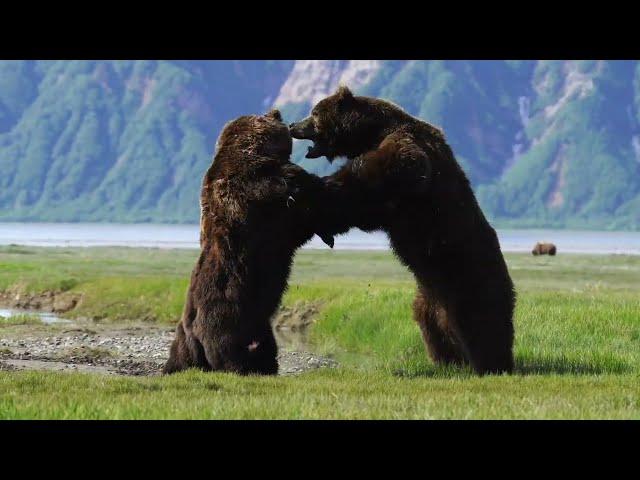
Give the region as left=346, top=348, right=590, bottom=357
left=0, top=223, right=640, bottom=255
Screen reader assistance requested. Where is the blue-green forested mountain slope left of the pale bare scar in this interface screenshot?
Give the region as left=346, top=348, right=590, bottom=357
left=0, top=61, right=292, bottom=222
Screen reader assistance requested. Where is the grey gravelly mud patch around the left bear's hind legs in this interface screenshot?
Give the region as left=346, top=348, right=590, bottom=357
left=0, top=306, right=337, bottom=375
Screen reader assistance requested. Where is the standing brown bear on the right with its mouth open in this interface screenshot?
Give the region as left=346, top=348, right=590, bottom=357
left=289, top=87, right=515, bottom=374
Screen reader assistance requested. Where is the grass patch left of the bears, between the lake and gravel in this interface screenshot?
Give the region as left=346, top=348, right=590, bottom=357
left=0, top=247, right=197, bottom=323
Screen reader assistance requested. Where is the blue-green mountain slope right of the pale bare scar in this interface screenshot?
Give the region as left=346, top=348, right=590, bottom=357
left=278, top=61, right=640, bottom=229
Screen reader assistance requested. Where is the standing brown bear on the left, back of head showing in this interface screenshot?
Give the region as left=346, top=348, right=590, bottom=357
left=163, top=110, right=333, bottom=374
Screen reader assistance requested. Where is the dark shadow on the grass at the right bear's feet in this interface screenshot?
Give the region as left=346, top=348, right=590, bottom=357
left=389, top=355, right=631, bottom=378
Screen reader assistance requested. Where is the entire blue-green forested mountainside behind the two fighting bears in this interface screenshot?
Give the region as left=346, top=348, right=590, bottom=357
left=0, top=60, right=640, bottom=229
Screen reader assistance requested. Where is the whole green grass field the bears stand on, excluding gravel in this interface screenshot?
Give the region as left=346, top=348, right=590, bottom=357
left=0, top=247, right=640, bottom=419
